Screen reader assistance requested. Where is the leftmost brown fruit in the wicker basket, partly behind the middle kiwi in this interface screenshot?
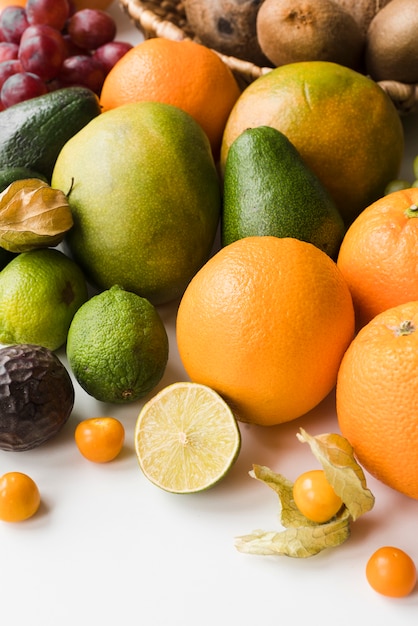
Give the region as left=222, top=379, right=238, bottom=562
left=183, top=0, right=271, bottom=66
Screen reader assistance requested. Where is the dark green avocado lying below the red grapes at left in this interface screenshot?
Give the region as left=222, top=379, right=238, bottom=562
left=0, top=87, right=101, bottom=182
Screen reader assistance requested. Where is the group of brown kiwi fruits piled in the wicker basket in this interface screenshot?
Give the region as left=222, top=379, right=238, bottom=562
left=182, top=0, right=418, bottom=83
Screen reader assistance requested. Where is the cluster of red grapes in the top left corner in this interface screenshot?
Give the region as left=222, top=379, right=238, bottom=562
left=0, top=0, right=132, bottom=110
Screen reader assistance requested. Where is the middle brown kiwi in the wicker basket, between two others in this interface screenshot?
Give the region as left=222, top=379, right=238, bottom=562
left=256, top=0, right=365, bottom=69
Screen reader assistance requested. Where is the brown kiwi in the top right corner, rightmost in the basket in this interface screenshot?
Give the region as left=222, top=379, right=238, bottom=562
left=365, top=0, right=418, bottom=83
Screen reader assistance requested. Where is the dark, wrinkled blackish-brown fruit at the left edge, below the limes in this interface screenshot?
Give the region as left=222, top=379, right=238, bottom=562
left=0, top=344, right=74, bottom=451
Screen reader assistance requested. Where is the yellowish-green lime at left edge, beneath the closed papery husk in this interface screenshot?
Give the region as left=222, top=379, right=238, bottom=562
left=0, top=248, right=88, bottom=350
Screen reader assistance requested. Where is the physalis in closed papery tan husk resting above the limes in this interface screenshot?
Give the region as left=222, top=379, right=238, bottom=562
left=0, top=178, right=73, bottom=253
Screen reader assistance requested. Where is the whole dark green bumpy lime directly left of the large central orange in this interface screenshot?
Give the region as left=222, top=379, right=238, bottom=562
left=67, top=285, right=168, bottom=403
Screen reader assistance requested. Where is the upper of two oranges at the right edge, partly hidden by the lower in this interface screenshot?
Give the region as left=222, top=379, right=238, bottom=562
left=337, top=188, right=418, bottom=328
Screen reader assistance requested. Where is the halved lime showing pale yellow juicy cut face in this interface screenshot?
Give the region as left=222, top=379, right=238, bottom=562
left=135, top=381, right=241, bottom=493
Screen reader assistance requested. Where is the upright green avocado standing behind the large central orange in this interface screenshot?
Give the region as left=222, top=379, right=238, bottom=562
left=221, top=126, right=345, bottom=259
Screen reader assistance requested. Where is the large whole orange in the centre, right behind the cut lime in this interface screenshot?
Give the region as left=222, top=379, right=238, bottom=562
left=176, top=236, right=354, bottom=425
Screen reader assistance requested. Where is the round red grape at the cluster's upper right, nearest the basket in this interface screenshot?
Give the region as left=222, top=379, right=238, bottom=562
left=67, top=9, right=116, bottom=50
